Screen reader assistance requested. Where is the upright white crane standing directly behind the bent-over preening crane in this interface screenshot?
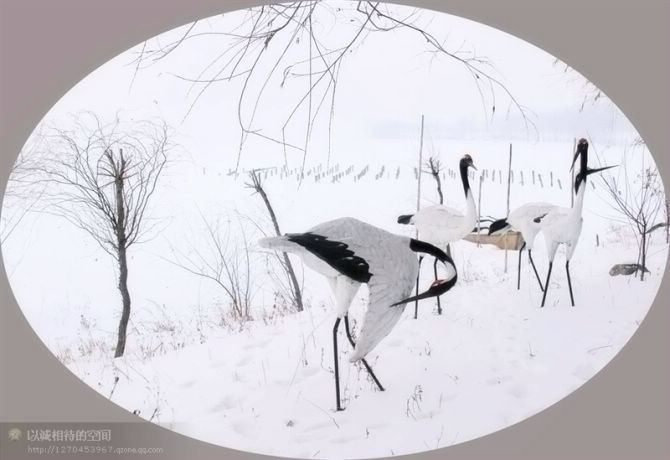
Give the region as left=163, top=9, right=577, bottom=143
left=398, top=154, right=478, bottom=318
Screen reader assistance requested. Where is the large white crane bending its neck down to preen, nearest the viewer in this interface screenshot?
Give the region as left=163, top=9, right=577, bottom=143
left=258, top=217, right=457, bottom=410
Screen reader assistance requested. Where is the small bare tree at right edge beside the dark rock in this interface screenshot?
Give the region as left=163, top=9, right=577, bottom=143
left=603, top=142, right=667, bottom=281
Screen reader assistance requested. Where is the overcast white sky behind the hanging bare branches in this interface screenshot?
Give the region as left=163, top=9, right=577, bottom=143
left=38, top=3, right=634, bottom=171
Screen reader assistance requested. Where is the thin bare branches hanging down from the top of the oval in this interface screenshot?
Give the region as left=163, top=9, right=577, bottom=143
left=134, top=0, right=532, bottom=167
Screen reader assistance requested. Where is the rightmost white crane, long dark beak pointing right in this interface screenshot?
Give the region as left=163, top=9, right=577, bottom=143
left=533, top=138, right=614, bottom=307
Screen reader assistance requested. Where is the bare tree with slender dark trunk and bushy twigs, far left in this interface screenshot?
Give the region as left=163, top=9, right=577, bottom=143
left=31, top=112, right=171, bottom=357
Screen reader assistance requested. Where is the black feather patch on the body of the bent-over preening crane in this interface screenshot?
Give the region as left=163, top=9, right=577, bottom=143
left=286, top=232, right=372, bottom=283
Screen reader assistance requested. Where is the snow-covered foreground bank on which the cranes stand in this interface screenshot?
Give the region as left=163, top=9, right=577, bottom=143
left=61, top=225, right=664, bottom=458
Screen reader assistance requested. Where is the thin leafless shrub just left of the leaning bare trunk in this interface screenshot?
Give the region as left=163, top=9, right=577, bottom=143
left=168, top=214, right=252, bottom=323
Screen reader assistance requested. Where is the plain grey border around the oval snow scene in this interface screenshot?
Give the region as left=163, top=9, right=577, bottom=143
left=0, top=0, right=670, bottom=460
